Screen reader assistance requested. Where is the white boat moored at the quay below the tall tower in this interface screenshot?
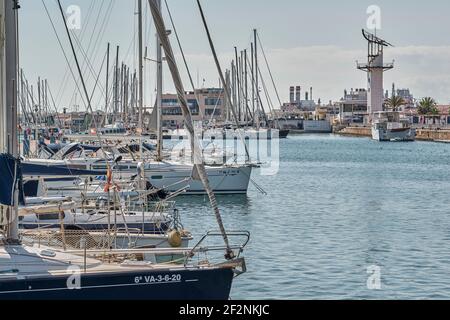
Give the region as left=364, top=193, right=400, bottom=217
left=372, top=111, right=416, bottom=142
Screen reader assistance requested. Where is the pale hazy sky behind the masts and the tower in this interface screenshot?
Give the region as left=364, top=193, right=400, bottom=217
left=16, top=0, right=450, bottom=109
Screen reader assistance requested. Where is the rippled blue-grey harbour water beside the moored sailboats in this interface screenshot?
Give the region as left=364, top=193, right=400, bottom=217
left=178, top=135, right=450, bottom=299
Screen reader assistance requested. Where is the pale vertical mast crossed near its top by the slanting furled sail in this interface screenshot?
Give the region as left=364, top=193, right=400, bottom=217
left=156, top=0, right=163, bottom=161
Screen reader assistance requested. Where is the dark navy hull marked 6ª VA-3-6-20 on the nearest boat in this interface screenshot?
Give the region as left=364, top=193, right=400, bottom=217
left=0, top=268, right=234, bottom=300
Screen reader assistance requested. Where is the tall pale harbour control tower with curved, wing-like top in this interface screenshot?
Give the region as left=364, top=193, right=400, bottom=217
left=357, top=30, right=394, bottom=117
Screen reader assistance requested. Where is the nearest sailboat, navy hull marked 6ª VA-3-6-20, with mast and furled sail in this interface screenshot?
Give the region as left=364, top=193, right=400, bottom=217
left=0, top=0, right=245, bottom=300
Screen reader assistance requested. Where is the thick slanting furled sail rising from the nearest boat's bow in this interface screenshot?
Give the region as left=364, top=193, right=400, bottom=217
left=149, top=0, right=235, bottom=260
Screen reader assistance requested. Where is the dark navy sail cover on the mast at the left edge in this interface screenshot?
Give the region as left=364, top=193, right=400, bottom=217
left=0, top=154, right=25, bottom=206
